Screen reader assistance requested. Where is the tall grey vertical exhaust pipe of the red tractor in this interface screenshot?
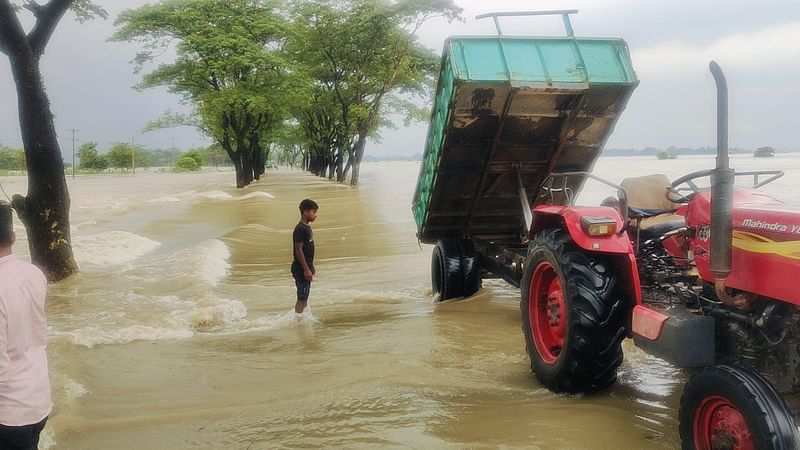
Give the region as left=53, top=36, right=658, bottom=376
left=708, top=61, right=734, bottom=303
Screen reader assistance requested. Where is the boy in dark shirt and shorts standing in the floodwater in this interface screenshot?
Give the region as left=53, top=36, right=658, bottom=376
left=292, top=199, right=319, bottom=314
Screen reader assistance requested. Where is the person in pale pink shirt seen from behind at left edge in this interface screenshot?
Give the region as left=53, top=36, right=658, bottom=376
left=0, top=202, right=52, bottom=450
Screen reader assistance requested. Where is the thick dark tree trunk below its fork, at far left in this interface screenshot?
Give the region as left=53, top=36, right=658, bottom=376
left=10, top=54, right=78, bottom=282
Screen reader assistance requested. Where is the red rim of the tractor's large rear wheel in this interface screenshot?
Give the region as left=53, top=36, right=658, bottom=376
left=528, top=262, right=567, bottom=364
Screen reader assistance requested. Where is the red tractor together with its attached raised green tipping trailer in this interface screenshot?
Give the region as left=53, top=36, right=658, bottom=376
left=412, top=14, right=800, bottom=450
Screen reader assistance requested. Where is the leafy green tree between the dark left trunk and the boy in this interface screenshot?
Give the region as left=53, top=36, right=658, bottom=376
left=112, top=0, right=294, bottom=187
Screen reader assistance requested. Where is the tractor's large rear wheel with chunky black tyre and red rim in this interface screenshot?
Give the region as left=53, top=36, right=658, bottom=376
left=520, top=230, right=625, bottom=393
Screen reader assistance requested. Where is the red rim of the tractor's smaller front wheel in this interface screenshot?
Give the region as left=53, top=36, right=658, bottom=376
left=692, top=396, right=755, bottom=450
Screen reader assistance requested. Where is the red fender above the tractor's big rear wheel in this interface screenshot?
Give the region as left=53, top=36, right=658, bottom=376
left=528, top=205, right=642, bottom=306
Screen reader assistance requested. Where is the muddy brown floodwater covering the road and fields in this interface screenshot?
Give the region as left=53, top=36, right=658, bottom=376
left=0, top=155, right=800, bottom=449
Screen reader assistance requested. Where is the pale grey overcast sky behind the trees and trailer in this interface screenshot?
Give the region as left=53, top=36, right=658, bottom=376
left=0, top=0, right=800, bottom=158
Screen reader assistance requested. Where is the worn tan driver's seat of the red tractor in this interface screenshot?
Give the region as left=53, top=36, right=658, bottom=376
left=622, top=174, right=686, bottom=238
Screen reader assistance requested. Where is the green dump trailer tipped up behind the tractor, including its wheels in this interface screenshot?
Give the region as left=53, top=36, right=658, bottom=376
left=412, top=11, right=638, bottom=299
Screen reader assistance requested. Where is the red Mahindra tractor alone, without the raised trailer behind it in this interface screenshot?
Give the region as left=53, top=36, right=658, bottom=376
left=520, top=62, right=800, bottom=449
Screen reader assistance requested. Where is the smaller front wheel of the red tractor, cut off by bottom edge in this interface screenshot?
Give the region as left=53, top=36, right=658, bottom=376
left=679, top=366, right=800, bottom=450
